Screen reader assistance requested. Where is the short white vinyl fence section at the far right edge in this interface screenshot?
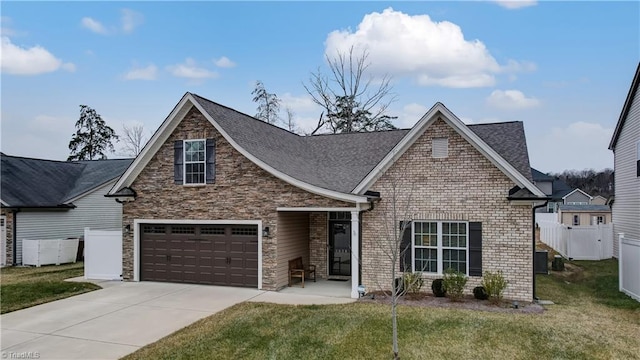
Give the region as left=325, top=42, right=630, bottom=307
left=618, top=233, right=640, bottom=301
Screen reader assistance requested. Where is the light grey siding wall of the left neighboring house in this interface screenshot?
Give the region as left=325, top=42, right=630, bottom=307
left=16, top=180, right=122, bottom=264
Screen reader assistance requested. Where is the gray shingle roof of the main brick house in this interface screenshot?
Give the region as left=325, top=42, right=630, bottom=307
left=192, top=94, right=531, bottom=193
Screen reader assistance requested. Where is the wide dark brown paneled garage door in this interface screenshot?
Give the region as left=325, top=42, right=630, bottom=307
left=140, top=224, right=258, bottom=287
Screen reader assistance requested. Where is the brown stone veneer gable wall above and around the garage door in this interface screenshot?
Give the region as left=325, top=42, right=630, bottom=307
left=122, top=108, right=353, bottom=290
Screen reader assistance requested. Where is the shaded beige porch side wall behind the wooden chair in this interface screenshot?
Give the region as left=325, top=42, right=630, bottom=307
left=276, top=212, right=309, bottom=288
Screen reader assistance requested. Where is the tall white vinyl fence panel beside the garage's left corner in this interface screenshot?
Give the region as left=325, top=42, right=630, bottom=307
left=84, top=228, right=122, bottom=280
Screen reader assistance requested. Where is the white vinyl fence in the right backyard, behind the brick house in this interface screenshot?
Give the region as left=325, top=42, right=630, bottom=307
left=538, top=221, right=613, bottom=260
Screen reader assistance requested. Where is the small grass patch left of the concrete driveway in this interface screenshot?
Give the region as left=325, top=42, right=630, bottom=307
left=0, top=262, right=100, bottom=314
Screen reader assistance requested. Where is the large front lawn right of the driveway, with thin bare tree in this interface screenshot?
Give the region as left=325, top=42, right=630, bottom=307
left=125, top=260, right=640, bottom=360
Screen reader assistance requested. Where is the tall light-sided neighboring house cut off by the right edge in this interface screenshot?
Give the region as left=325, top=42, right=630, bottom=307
left=609, top=64, right=640, bottom=261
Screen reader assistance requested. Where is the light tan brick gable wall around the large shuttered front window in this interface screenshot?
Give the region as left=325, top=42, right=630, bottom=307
left=362, top=119, right=533, bottom=301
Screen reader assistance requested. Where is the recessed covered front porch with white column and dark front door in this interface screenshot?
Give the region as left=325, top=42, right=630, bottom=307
left=276, top=207, right=360, bottom=298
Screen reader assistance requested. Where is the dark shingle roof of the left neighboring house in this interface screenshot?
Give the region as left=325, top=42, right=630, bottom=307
left=0, top=154, right=132, bottom=207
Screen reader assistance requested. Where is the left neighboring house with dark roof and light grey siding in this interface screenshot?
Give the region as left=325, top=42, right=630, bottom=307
left=0, top=154, right=132, bottom=265
